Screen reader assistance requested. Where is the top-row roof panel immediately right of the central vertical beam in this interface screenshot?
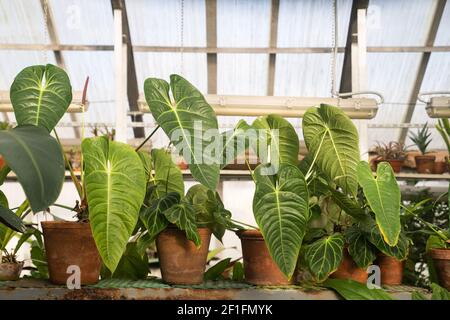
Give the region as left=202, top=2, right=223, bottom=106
left=217, top=0, right=271, bottom=47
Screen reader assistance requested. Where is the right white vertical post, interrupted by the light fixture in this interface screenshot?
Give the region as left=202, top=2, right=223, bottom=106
left=351, top=9, right=369, bottom=160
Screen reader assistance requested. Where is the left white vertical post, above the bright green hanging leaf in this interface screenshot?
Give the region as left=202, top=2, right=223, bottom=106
left=114, top=9, right=127, bottom=143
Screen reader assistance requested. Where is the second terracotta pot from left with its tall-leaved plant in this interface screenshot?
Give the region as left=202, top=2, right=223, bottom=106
left=141, top=75, right=244, bottom=284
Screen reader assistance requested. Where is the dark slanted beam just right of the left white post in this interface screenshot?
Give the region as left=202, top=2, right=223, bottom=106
left=111, top=0, right=145, bottom=138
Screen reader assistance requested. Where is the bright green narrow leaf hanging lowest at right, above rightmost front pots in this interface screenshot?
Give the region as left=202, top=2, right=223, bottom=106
left=357, top=161, right=401, bottom=246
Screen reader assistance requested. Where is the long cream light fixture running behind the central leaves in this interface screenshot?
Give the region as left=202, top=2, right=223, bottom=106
left=138, top=94, right=378, bottom=119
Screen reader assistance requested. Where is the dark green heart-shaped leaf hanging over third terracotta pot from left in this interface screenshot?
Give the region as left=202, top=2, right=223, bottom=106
left=253, top=164, right=309, bottom=278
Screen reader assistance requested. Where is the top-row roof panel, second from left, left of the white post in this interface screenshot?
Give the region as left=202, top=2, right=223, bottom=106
left=49, top=0, right=114, bottom=45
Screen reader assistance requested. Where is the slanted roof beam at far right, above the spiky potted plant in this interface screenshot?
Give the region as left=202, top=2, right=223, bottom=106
left=398, top=0, right=447, bottom=143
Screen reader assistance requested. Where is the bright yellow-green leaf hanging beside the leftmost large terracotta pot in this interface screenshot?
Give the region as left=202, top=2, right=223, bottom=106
left=81, top=137, right=146, bottom=272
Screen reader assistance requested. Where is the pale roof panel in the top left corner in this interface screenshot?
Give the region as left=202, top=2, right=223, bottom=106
left=0, top=0, right=49, bottom=44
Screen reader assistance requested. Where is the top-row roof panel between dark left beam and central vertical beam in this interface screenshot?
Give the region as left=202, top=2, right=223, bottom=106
left=126, top=0, right=206, bottom=47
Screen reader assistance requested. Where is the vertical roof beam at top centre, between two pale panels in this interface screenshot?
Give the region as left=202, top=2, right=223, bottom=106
left=206, top=0, right=217, bottom=94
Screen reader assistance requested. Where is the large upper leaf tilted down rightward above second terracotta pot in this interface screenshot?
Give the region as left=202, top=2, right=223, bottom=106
left=144, top=74, right=221, bottom=190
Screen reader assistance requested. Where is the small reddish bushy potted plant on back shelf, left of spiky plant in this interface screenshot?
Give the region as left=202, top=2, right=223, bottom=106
left=373, top=141, right=407, bottom=173
